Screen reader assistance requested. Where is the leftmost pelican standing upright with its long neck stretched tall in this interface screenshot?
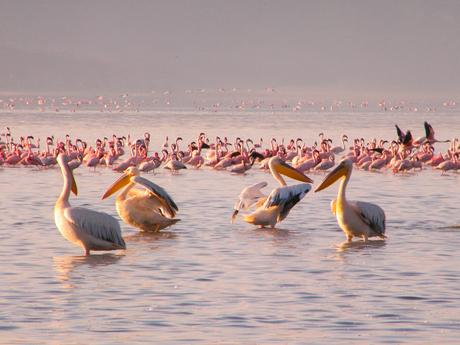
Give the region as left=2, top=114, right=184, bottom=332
left=54, top=154, right=126, bottom=255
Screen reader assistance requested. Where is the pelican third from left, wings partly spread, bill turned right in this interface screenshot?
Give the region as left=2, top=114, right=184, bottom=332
left=232, top=156, right=313, bottom=228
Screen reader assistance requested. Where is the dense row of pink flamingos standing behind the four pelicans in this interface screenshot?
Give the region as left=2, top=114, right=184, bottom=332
left=0, top=122, right=460, bottom=174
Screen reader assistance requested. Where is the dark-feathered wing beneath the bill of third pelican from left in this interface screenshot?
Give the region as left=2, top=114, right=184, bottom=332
left=263, top=183, right=311, bottom=221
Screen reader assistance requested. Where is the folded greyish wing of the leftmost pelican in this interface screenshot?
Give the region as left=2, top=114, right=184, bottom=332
left=64, top=207, right=126, bottom=249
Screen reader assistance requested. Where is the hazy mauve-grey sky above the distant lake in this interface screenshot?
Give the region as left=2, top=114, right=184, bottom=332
left=0, top=0, right=460, bottom=97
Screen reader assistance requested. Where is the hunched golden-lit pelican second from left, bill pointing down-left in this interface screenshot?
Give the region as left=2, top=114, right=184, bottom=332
left=102, top=167, right=179, bottom=231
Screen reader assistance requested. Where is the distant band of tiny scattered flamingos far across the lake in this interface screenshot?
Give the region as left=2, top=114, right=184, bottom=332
left=0, top=92, right=458, bottom=113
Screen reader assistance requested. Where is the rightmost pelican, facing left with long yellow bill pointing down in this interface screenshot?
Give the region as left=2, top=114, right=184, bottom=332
left=315, top=159, right=385, bottom=242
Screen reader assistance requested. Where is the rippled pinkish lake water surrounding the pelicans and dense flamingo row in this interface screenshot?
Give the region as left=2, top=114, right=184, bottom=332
left=0, top=111, right=460, bottom=344
